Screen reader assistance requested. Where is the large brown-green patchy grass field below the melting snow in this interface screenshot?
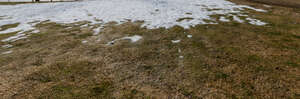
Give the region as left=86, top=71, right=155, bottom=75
left=0, top=0, right=300, bottom=99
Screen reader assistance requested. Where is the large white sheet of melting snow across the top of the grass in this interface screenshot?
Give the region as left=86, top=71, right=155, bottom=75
left=0, top=0, right=266, bottom=41
